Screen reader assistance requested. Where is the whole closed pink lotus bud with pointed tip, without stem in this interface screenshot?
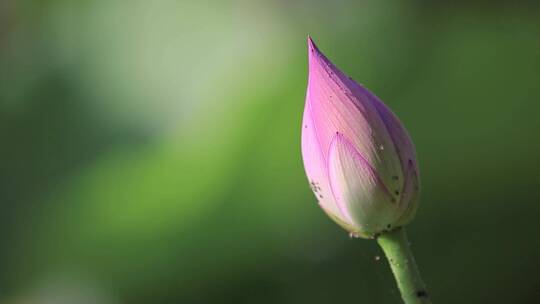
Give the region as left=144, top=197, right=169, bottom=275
left=302, top=37, right=419, bottom=238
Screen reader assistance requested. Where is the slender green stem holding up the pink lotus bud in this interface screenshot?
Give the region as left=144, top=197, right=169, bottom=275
left=377, top=228, right=431, bottom=304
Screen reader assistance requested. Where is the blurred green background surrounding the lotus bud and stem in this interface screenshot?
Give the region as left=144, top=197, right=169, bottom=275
left=0, top=0, right=540, bottom=304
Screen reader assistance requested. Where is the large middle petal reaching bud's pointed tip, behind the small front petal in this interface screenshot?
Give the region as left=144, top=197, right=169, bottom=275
left=306, top=39, right=403, bottom=189
